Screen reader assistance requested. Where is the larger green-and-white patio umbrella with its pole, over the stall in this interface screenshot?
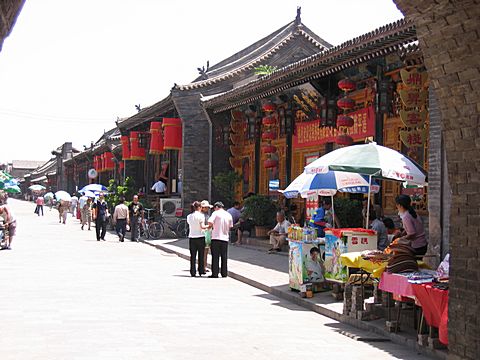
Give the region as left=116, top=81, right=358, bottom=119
left=305, top=142, right=427, bottom=225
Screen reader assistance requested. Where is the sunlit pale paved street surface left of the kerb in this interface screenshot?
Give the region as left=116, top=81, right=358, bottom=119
left=0, top=200, right=424, bottom=360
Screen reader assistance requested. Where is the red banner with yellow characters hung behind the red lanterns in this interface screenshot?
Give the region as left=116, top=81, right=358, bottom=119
left=293, top=106, right=375, bottom=148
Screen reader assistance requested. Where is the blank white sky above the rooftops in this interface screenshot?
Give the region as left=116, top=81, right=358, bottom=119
left=0, top=0, right=403, bottom=163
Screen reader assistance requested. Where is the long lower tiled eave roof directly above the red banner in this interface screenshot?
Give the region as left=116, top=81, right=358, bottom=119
left=203, top=19, right=417, bottom=112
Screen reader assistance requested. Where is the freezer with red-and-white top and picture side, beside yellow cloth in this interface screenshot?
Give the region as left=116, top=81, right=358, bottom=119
left=325, top=228, right=377, bottom=282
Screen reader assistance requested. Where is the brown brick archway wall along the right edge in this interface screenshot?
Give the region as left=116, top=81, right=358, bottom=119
left=394, top=0, right=480, bottom=359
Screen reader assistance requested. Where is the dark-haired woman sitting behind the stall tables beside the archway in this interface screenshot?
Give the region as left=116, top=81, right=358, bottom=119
left=395, top=195, right=428, bottom=255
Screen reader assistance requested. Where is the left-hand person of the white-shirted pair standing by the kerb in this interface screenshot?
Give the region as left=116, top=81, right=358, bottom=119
left=187, top=201, right=208, bottom=277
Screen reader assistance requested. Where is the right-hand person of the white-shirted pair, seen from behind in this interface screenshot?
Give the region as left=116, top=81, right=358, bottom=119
left=208, top=201, right=233, bottom=278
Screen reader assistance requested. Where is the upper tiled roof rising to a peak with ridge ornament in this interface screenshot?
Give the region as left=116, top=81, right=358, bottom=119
left=175, top=21, right=332, bottom=91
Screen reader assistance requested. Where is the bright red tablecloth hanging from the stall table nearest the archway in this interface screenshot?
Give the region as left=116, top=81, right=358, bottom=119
left=412, top=284, right=448, bottom=344
